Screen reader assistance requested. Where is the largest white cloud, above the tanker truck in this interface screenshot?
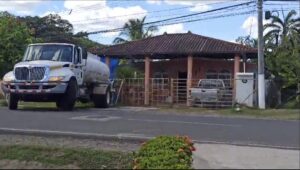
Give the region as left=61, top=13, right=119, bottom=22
left=54, top=0, right=147, bottom=37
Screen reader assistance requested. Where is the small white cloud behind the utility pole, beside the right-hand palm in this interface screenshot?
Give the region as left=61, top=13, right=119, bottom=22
left=242, top=16, right=270, bottom=38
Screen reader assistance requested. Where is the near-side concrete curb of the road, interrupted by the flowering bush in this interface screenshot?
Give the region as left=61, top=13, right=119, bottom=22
left=0, top=128, right=300, bottom=150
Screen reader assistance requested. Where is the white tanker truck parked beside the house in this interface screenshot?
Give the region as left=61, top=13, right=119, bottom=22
left=1, top=43, right=111, bottom=110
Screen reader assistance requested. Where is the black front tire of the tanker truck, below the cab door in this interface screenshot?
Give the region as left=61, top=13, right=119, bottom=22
left=56, top=79, right=78, bottom=111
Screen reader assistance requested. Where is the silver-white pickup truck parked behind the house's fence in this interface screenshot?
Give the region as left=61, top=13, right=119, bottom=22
left=190, top=79, right=225, bottom=104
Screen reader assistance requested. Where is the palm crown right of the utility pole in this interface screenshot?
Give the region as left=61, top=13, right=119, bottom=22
left=264, top=10, right=300, bottom=46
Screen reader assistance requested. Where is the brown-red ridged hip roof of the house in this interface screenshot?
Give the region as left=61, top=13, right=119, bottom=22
left=99, top=33, right=257, bottom=58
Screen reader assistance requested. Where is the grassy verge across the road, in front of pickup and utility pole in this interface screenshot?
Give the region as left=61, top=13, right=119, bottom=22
left=159, top=106, right=300, bottom=120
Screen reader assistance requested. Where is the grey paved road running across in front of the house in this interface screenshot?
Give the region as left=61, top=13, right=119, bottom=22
left=0, top=107, right=300, bottom=149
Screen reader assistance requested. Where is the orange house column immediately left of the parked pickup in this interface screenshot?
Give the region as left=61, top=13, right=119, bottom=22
left=186, top=55, right=193, bottom=106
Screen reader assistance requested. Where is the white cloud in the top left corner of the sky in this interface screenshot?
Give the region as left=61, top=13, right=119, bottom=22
left=0, top=0, right=43, bottom=15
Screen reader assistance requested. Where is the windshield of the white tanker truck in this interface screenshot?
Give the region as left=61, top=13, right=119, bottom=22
left=23, top=45, right=73, bottom=62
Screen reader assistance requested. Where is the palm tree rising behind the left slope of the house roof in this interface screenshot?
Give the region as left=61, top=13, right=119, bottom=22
left=113, top=17, right=157, bottom=44
